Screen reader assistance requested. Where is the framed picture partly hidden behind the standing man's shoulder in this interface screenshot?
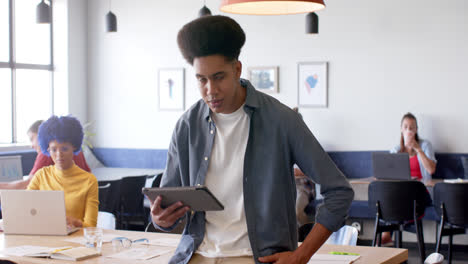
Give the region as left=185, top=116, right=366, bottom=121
left=247, top=66, right=278, bottom=93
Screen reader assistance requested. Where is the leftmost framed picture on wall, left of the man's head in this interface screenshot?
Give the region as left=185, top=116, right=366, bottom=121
left=158, top=68, right=185, bottom=111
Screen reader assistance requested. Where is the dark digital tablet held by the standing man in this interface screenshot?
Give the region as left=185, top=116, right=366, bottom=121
left=142, top=186, right=224, bottom=211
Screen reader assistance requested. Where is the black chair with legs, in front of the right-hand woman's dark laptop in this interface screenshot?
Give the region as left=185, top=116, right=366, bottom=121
left=369, top=181, right=430, bottom=263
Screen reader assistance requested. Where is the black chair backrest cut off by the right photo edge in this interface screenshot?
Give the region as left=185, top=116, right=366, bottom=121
left=434, top=182, right=468, bottom=226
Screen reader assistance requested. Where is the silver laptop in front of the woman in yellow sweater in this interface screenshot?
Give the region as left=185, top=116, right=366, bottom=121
left=0, top=190, right=79, bottom=235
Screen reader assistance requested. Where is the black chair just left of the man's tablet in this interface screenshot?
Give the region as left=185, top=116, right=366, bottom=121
left=117, top=175, right=147, bottom=231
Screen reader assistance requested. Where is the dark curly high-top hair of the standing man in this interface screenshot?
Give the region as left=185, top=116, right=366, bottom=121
left=177, top=16, right=245, bottom=65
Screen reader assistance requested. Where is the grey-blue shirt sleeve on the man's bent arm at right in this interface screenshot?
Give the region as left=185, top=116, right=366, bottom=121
left=290, top=115, right=354, bottom=232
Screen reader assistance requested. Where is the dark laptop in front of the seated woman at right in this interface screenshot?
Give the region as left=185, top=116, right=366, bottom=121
left=372, top=152, right=411, bottom=180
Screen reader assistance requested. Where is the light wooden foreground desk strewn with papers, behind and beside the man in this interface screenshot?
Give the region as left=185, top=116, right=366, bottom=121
left=0, top=230, right=408, bottom=264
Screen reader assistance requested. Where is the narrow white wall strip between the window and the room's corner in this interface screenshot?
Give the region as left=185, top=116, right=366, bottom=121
left=53, top=0, right=88, bottom=123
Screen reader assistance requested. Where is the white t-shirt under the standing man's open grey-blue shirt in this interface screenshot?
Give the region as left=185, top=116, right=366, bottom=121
left=197, top=105, right=252, bottom=258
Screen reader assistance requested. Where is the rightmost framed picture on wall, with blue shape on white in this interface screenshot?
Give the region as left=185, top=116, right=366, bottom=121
left=297, top=62, right=328, bottom=107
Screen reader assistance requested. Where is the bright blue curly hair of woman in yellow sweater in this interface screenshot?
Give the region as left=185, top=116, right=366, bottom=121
left=37, top=115, right=83, bottom=156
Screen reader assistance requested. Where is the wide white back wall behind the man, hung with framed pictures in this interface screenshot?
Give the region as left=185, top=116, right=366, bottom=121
left=88, top=0, right=468, bottom=152
